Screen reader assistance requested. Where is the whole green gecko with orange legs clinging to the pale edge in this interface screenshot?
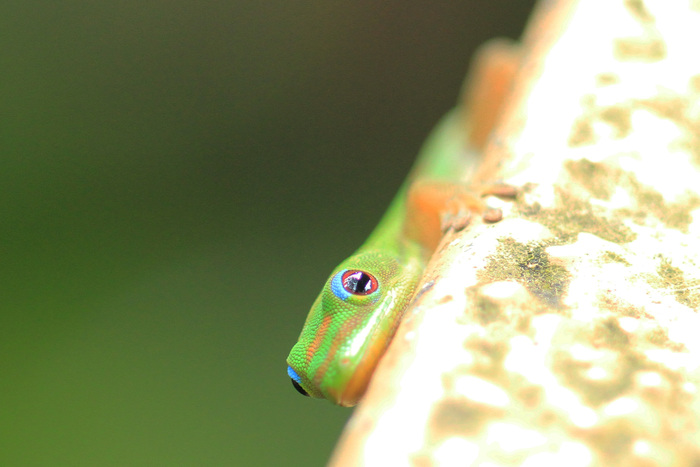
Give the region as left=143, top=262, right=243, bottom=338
left=287, top=42, right=516, bottom=407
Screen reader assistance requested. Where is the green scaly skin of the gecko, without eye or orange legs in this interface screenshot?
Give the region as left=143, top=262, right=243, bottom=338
left=287, top=111, right=476, bottom=407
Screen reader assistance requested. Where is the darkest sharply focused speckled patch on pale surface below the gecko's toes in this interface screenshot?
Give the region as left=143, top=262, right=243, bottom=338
left=478, top=238, right=571, bottom=309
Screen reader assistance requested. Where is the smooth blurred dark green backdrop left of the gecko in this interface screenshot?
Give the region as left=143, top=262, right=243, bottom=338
left=0, top=0, right=532, bottom=466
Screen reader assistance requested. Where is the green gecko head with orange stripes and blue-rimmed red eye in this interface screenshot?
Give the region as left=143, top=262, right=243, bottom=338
left=287, top=251, right=417, bottom=406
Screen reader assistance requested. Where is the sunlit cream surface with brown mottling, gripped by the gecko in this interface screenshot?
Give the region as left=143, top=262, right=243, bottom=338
left=332, top=0, right=700, bottom=466
